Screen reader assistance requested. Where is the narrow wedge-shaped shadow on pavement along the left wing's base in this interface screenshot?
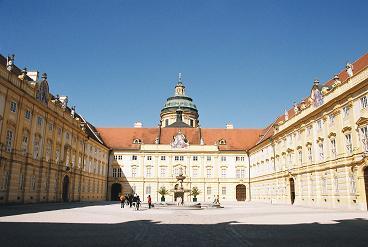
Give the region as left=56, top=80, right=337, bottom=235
left=0, top=201, right=119, bottom=217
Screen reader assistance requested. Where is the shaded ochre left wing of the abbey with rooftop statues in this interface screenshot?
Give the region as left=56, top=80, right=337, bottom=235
left=0, top=56, right=109, bottom=204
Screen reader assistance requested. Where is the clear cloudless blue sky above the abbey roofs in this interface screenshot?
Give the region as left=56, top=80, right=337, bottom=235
left=0, top=0, right=368, bottom=128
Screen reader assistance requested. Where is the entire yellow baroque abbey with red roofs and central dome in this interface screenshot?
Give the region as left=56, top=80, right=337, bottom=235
left=0, top=54, right=368, bottom=210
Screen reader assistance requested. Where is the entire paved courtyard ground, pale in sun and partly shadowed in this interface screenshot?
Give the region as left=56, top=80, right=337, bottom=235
left=0, top=202, right=368, bottom=247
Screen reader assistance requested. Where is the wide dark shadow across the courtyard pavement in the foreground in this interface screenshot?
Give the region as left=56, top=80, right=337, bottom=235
left=0, top=219, right=368, bottom=247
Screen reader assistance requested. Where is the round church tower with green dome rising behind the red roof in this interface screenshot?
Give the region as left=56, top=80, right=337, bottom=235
left=160, top=73, right=199, bottom=128
